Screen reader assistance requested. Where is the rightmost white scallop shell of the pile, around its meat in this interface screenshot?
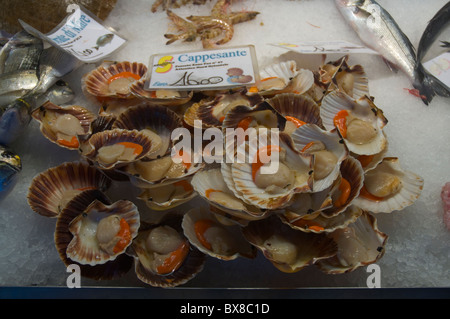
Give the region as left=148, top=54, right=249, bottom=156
left=354, top=157, right=424, bottom=213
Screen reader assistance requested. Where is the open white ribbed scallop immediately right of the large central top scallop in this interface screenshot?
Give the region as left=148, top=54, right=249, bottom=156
left=291, top=124, right=348, bottom=192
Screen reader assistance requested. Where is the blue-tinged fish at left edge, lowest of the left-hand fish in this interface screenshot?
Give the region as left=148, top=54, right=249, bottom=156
left=0, top=145, right=22, bottom=201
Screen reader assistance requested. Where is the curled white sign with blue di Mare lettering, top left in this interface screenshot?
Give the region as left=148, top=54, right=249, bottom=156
left=20, top=5, right=126, bottom=63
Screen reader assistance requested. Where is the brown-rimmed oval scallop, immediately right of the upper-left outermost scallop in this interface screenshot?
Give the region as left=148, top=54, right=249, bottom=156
left=80, top=128, right=154, bottom=169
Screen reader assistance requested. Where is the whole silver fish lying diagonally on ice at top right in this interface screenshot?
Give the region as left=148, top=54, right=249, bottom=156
left=335, top=0, right=435, bottom=105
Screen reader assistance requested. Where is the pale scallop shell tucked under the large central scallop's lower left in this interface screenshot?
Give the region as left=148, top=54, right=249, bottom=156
left=191, top=168, right=267, bottom=220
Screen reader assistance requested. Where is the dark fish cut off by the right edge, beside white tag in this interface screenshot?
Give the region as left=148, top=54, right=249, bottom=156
left=416, top=1, right=450, bottom=97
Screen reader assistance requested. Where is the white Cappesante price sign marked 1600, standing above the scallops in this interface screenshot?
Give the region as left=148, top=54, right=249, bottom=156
left=144, top=45, right=259, bottom=90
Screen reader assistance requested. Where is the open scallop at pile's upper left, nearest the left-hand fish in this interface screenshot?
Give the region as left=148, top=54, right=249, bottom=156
left=31, top=101, right=96, bottom=150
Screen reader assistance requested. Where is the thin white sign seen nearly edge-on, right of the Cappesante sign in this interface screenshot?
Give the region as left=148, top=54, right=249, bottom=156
left=271, top=41, right=378, bottom=54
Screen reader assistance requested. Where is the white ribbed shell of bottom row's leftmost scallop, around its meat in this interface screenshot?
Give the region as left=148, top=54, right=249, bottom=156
left=66, top=200, right=140, bottom=266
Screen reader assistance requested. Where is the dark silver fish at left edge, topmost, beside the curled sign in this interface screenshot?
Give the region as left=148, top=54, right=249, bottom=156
left=0, top=31, right=44, bottom=74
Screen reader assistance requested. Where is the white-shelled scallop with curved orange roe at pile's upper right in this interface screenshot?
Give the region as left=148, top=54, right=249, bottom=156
left=320, top=91, right=387, bottom=155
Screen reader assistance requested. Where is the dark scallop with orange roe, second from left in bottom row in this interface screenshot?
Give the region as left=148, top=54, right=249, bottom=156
left=129, top=215, right=206, bottom=287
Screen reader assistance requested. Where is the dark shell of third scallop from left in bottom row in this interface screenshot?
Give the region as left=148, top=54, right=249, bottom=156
left=181, top=207, right=256, bottom=261
